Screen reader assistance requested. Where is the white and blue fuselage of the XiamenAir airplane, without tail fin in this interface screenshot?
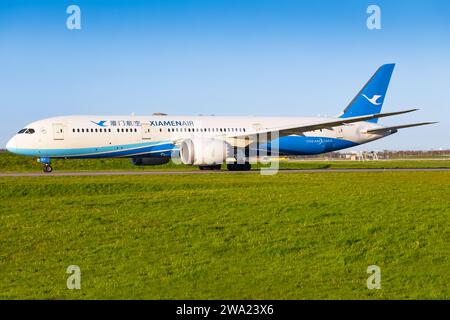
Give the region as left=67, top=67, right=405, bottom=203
left=7, top=115, right=383, bottom=158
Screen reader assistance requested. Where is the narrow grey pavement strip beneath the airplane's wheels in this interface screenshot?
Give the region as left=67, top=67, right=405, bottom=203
left=0, top=168, right=450, bottom=177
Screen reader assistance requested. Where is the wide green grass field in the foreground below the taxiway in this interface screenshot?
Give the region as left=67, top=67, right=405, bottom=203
left=0, top=172, right=450, bottom=299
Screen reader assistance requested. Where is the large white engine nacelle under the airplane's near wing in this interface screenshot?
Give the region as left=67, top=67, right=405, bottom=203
left=180, top=138, right=227, bottom=166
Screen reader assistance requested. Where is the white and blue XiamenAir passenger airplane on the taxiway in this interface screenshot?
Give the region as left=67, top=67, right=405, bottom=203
left=6, top=64, right=436, bottom=173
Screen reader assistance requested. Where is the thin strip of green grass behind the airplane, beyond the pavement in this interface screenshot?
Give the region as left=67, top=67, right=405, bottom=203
left=0, top=152, right=450, bottom=172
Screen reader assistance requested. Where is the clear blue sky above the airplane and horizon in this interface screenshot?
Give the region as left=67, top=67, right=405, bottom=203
left=0, top=0, right=450, bottom=150
